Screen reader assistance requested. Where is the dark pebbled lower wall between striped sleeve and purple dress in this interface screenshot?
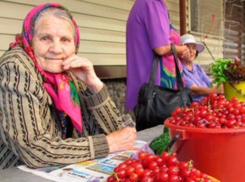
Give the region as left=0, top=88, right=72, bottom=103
left=102, top=78, right=135, bottom=121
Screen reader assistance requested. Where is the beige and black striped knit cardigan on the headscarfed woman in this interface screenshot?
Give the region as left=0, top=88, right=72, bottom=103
left=0, top=47, right=122, bottom=168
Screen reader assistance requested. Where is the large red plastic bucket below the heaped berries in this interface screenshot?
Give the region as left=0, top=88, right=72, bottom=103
left=164, top=120, right=245, bottom=182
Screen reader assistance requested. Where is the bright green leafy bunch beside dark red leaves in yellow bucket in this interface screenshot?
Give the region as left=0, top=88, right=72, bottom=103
left=211, top=58, right=231, bottom=87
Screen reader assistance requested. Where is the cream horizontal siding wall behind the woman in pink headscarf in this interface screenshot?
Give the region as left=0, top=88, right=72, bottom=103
left=0, top=0, right=179, bottom=66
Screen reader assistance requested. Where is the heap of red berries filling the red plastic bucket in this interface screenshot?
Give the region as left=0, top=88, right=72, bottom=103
left=169, top=93, right=245, bottom=129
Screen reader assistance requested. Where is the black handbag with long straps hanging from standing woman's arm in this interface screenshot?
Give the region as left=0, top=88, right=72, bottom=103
left=134, top=44, right=192, bottom=130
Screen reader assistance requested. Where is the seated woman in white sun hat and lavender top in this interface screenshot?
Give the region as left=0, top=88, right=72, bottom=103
left=181, top=34, right=223, bottom=102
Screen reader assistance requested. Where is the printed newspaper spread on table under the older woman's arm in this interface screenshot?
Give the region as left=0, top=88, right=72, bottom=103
left=18, top=140, right=146, bottom=182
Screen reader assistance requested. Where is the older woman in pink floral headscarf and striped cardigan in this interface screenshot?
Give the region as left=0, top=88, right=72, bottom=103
left=0, top=3, right=136, bottom=168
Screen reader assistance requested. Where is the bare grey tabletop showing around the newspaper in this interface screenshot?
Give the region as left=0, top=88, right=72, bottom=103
left=0, top=125, right=163, bottom=182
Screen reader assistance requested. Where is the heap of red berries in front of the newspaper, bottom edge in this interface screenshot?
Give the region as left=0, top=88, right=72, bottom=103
left=107, top=151, right=212, bottom=182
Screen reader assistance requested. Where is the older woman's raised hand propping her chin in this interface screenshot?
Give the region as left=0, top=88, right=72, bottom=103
left=63, top=54, right=103, bottom=93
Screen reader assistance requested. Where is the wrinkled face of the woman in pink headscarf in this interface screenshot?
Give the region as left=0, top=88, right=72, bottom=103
left=32, top=15, right=75, bottom=73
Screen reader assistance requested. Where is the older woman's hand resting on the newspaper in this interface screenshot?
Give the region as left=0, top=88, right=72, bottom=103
left=106, top=127, right=137, bottom=153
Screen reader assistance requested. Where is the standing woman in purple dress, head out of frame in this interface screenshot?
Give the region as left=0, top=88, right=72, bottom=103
left=126, top=0, right=189, bottom=130
